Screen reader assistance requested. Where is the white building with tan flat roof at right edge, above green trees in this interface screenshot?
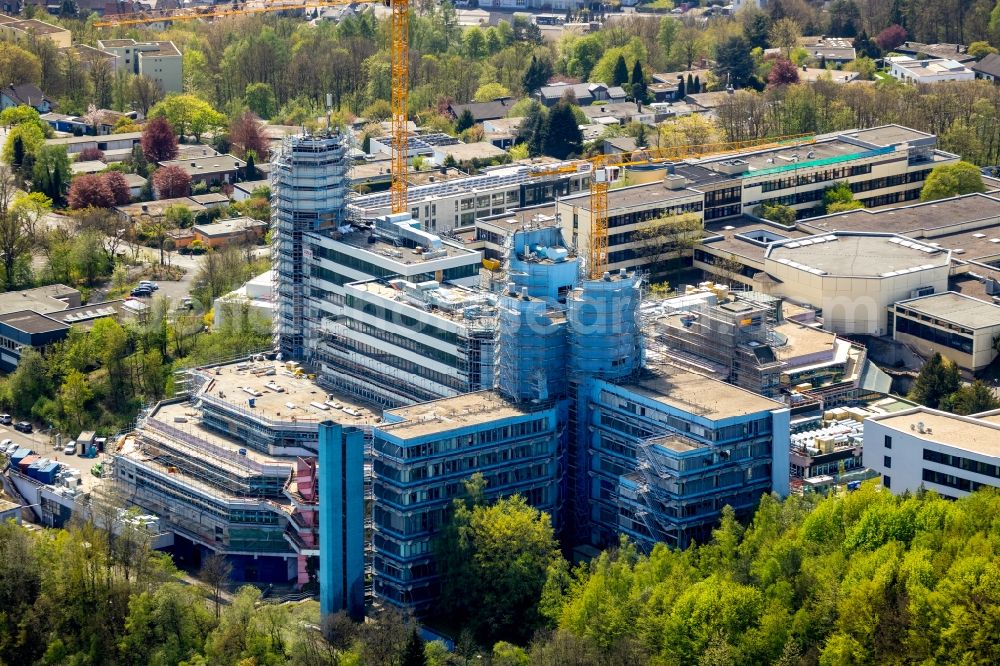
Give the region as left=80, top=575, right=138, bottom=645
left=864, top=407, right=1000, bottom=498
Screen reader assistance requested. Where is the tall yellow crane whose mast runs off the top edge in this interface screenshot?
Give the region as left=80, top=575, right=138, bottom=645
left=94, top=0, right=410, bottom=213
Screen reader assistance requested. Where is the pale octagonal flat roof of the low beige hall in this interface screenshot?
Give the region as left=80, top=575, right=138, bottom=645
left=766, top=233, right=950, bottom=278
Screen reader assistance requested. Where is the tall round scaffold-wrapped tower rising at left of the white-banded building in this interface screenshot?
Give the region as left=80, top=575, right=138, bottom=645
left=271, top=132, right=348, bottom=359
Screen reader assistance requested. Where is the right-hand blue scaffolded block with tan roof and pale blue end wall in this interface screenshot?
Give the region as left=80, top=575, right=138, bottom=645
left=583, top=366, right=789, bottom=549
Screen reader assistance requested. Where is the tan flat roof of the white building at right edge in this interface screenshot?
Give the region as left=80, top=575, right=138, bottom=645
left=872, top=407, right=1000, bottom=456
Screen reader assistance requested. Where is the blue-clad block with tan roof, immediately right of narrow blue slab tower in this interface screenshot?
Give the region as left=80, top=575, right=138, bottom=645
left=373, top=391, right=565, bottom=613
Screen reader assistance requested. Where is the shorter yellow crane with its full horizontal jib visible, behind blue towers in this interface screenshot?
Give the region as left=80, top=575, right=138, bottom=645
left=531, top=134, right=815, bottom=280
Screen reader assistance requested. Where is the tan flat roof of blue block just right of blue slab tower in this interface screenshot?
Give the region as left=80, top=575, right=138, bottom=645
left=378, top=391, right=531, bottom=439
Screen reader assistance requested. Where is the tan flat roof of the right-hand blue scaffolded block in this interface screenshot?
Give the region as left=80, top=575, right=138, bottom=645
left=623, top=365, right=785, bottom=420
